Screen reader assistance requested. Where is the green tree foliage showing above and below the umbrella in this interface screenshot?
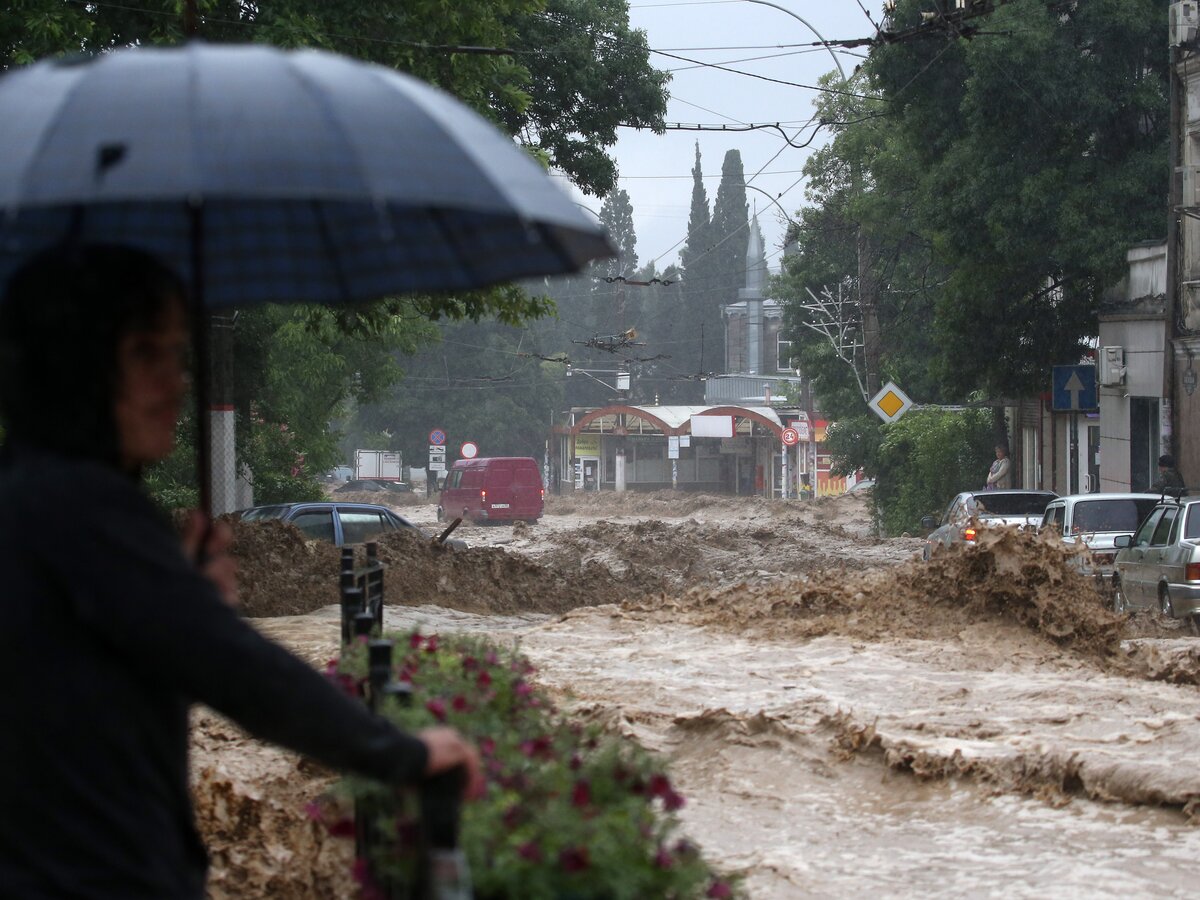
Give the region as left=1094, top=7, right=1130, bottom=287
left=0, top=0, right=668, bottom=500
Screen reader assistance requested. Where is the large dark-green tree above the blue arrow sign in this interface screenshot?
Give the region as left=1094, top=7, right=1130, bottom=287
left=869, top=0, right=1168, bottom=397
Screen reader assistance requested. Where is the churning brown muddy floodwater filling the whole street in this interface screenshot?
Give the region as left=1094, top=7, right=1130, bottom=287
left=206, top=498, right=1200, bottom=898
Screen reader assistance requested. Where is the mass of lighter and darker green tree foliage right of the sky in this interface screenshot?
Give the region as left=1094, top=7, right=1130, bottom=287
left=778, top=0, right=1168, bottom=413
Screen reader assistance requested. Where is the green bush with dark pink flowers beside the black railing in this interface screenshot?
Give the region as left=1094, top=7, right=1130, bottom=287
left=328, top=632, right=739, bottom=900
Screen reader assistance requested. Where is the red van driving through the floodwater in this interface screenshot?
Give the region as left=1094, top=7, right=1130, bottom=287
left=438, top=456, right=546, bottom=523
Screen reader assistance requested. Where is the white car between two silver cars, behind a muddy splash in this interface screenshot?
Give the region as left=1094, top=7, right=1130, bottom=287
left=1039, top=493, right=1162, bottom=590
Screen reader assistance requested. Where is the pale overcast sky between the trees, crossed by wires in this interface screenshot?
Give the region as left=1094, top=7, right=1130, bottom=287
left=566, top=0, right=882, bottom=271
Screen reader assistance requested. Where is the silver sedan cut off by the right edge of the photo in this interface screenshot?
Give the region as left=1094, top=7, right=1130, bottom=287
left=1112, top=497, right=1200, bottom=631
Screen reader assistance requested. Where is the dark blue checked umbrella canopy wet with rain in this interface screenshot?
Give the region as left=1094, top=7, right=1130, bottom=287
left=0, top=42, right=612, bottom=307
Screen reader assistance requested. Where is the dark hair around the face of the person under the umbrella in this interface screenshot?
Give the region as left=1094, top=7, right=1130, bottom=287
left=0, top=244, right=185, bottom=466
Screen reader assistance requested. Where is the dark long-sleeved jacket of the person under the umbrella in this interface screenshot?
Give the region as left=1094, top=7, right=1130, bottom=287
left=0, top=455, right=426, bottom=899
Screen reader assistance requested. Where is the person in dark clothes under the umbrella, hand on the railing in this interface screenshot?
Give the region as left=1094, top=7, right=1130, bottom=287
left=0, top=244, right=482, bottom=899
